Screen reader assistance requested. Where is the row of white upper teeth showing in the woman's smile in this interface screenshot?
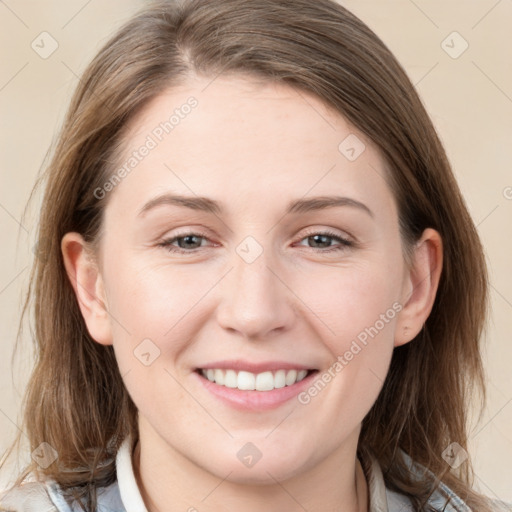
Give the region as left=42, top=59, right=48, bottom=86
left=201, top=368, right=308, bottom=391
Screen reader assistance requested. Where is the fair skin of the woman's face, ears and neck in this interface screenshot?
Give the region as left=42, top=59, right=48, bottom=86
left=62, top=76, right=442, bottom=512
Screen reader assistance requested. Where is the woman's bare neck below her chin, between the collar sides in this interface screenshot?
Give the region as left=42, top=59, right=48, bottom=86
left=132, top=426, right=368, bottom=512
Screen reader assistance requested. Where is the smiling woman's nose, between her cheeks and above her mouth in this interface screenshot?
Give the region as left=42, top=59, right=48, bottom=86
left=217, top=243, right=295, bottom=341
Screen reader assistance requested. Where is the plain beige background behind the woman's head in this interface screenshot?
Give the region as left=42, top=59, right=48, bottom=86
left=0, top=0, right=512, bottom=501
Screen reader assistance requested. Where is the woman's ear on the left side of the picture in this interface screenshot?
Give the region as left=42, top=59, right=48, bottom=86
left=61, top=232, right=112, bottom=345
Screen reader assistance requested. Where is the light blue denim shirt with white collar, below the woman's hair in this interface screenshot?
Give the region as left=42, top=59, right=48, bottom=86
left=0, top=438, right=512, bottom=512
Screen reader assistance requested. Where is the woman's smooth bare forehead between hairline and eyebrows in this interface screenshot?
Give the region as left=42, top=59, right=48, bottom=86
left=107, top=73, right=393, bottom=220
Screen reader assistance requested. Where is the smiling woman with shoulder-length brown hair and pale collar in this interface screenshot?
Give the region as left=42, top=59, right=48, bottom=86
left=0, top=0, right=508, bottom=512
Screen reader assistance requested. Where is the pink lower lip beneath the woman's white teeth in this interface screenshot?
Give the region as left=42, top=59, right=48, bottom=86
left=194, top=371, right=318, bottom=411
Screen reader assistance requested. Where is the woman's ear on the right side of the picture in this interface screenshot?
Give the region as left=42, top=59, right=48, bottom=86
left=394, top=228, right=443, bottom=347
